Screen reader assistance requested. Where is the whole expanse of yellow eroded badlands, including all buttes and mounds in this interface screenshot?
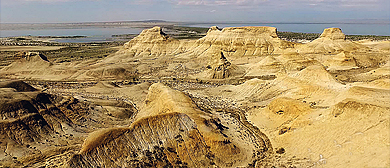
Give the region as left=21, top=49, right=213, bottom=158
left=0, top=27, right=390, bottom=168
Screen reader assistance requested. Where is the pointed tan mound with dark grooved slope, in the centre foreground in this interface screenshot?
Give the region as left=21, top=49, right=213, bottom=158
left=69, top=84, right=272, bottom=167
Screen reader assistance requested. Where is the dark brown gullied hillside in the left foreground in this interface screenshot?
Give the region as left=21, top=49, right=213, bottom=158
left=0, top=81, right=136, bottom=167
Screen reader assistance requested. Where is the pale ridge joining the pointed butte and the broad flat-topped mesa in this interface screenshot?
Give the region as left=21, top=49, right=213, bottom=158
left=107, top=26, right=294, bottom=61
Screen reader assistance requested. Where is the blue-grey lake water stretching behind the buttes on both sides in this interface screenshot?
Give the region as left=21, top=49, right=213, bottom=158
left=0, top=23, right=390, bottom=43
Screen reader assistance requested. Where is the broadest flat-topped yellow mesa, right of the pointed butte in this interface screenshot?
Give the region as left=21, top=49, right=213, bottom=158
left=189, top=26, right=294, bottom=57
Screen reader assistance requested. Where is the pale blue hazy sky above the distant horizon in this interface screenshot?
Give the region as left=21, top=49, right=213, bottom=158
left=0, top=0, right=390, bottom=23
